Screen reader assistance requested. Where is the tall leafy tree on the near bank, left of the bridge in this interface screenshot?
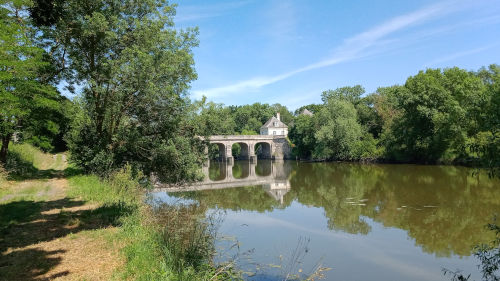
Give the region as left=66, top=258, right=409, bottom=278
left=41, top=0, right=203, bottom=181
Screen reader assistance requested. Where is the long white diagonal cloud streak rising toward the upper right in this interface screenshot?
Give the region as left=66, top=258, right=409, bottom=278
left=193, top=1, right=474, bottom=98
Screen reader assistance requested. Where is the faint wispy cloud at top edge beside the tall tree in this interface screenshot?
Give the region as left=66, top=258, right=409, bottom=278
left=175, top=0, right=252, bottom=23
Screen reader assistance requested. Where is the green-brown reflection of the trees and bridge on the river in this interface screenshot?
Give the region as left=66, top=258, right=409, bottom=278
left=163, top=160, right=500, bottom=257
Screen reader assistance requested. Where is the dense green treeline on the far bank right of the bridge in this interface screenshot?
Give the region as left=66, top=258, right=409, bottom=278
left=290, top=65, right=500, bottom=167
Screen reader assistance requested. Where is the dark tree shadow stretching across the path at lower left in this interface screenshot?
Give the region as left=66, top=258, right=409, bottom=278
left=0, top=198, right=133, bottom=280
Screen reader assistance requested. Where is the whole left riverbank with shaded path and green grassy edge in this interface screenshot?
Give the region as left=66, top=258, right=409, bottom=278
left=0, top=145, right=236, bottom=280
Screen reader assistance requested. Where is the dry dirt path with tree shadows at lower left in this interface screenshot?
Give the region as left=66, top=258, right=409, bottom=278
left=0, top=174, right=123, bottom=280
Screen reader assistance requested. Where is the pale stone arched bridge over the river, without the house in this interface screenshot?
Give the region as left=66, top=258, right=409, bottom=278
left=207, top=135, right=291, bottom=163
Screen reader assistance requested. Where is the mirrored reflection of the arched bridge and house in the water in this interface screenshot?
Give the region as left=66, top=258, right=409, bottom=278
left=159, top=160, right=292, bottom=204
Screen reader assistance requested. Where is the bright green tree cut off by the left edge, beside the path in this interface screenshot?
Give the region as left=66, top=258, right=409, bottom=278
left=0, top=1, right=61, bottom=163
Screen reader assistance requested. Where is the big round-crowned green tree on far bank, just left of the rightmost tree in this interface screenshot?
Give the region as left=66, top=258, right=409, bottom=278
left=393, top=68, right=483, bottom=162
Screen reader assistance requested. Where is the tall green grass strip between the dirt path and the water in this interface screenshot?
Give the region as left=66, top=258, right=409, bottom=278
left=69, top=166, right=236, bottom=281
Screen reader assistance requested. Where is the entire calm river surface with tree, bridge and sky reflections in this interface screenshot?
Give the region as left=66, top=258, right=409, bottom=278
left=154, top=160, right=500, bottom=281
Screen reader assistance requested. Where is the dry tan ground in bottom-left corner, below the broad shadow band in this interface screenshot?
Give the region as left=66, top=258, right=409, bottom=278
left=0, top=228, right=123, bottom=280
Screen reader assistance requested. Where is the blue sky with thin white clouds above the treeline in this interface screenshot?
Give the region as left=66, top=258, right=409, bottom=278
left=175, top=0, right=500, bottom=110
